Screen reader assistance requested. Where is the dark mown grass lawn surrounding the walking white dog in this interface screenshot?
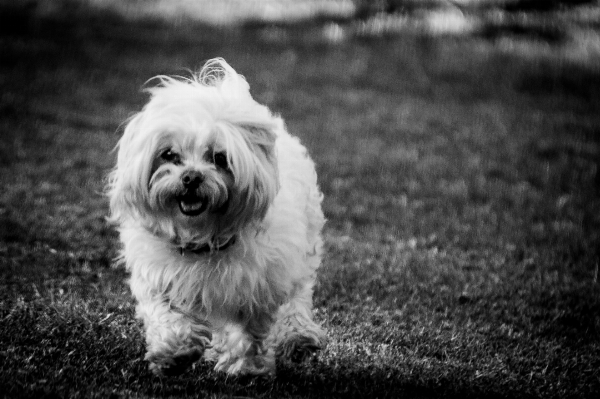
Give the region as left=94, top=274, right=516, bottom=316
left=0, top=6, right=600, bottom=398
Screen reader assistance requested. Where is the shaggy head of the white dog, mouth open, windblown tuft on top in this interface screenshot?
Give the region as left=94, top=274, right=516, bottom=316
left=109, top=60, right=282, bottom=245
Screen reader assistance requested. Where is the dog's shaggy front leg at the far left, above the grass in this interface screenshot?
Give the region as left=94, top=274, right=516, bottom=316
left=136, top=296, right=211, bottom=375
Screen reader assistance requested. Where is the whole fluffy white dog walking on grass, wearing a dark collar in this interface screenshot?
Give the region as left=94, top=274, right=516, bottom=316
left=108, top=59, right=325, bottom=374
